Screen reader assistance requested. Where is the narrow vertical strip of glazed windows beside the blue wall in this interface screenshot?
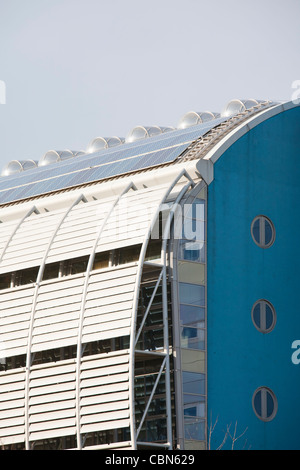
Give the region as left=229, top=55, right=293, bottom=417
left=177, top=188, right=206, bottom=449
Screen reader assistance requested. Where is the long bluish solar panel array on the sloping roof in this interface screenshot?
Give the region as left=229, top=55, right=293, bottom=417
left=0, top=117, right=228, bottom=204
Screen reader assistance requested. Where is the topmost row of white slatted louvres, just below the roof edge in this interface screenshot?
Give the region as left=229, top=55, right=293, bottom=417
left=0, top=185, right=166, bottom=274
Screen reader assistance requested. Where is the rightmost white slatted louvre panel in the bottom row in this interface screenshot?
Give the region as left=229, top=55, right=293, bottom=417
left=80, top=350, right=129, bottom=433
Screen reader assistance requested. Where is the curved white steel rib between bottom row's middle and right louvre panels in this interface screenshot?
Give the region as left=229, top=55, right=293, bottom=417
left=76, top=182, right=135, bottom=450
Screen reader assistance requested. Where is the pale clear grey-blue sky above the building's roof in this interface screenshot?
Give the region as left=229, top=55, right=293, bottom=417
left=0, top=0, right=300, bottom=170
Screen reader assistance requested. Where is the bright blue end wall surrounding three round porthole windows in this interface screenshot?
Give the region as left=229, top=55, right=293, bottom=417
left=207, top=107, right=300, bottom=450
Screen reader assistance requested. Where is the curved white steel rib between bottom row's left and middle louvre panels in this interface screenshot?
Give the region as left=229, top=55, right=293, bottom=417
left=25, top=194, right=84, bottom=450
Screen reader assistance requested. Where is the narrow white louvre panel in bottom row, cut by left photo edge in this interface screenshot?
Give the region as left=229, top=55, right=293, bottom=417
left=0, top=369, right=25, bottom=445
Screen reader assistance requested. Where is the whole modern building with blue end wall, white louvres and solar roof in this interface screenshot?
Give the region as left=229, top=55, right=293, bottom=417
left=0, top=100, right=300, bottom=451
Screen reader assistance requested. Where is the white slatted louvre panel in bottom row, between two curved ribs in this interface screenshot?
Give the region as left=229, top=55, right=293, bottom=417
left=29, top=360, right=76, bottom=441
